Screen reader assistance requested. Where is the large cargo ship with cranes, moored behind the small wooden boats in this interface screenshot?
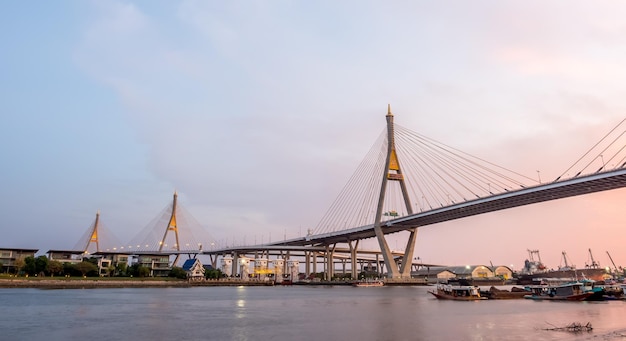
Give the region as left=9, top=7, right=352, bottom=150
left=517, top=250, right=611, bottom=285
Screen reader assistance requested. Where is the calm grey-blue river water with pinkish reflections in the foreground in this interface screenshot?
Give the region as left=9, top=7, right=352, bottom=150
left=0, top=286, right=626, bottom=341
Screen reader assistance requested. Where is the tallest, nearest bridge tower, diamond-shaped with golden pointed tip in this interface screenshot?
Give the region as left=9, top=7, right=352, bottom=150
left=374, top=105, right=417, bottom=278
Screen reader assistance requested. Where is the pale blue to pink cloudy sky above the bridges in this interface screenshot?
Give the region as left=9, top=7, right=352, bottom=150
left=0, top=0, right=626, bottom=268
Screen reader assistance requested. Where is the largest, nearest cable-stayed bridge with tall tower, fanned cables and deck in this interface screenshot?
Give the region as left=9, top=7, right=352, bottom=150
left=224, top=108, right=626, bottom=278
